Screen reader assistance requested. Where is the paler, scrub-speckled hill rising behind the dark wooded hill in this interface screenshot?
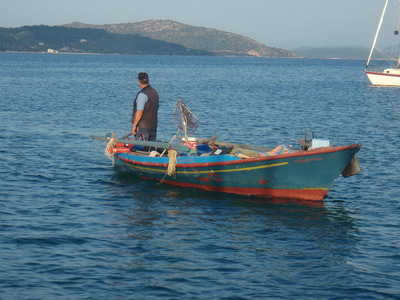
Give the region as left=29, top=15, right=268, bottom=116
left=64, top=20, right=296, bottom=57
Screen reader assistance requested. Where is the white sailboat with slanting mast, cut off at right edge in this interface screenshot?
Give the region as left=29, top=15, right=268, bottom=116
left=365, top=0, right=400, bottom=86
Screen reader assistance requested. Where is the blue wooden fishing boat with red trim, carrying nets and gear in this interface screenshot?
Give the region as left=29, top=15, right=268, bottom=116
left=92, top=100, right=361, bottom=201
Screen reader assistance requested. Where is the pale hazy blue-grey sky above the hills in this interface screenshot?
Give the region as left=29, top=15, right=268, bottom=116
left=0, top=0, right=398, bottom=49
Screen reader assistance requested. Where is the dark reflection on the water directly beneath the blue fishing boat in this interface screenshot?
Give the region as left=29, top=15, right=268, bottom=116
left=104, top=174, right=358, bottom=250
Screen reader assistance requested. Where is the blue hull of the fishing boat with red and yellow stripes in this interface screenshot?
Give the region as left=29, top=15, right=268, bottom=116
left=114, top=144, right=361, bottom=200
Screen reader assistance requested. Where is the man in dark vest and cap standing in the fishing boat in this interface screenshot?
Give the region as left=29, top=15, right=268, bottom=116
left=131, top=72, right=159, bottom=141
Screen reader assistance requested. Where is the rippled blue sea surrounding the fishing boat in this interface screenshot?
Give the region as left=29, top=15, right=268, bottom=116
left=0, top=53, right=400, bottom=299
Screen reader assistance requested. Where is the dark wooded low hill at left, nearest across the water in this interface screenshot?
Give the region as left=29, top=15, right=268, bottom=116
left=0, top=25, right=211, bottom=55
